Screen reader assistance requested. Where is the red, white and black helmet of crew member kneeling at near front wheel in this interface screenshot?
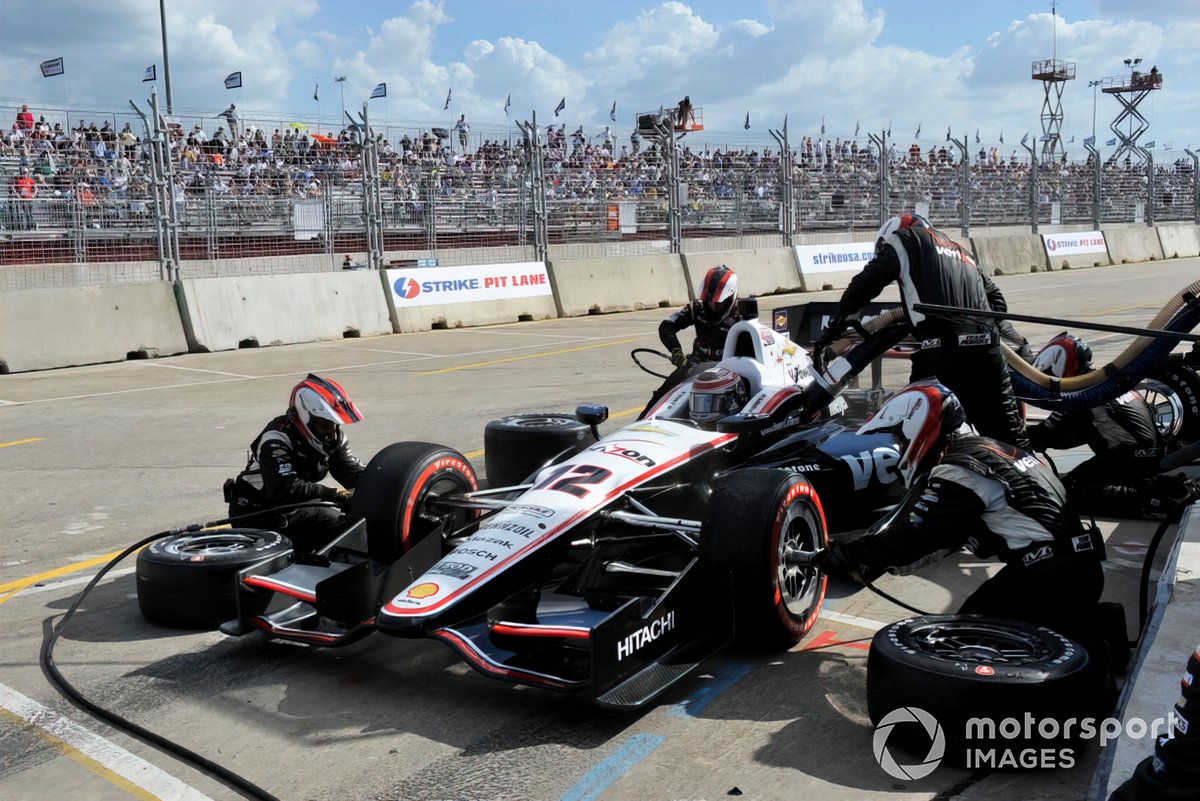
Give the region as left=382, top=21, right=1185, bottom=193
left=858, top=380, right=971, bottom=487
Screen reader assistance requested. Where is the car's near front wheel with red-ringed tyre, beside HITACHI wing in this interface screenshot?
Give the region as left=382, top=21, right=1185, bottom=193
left=700, top=468, right=828, bottom=649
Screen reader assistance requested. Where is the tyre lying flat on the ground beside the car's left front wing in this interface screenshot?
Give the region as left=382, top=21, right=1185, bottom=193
left=136, top=529, right=292, bottom=628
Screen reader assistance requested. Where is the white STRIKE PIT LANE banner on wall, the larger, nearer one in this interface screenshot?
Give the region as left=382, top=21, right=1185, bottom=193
left=388, top=261, right=551, bottom=309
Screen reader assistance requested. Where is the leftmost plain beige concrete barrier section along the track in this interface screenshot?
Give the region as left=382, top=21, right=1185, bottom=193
left=0, top=282, right=187, bottom=372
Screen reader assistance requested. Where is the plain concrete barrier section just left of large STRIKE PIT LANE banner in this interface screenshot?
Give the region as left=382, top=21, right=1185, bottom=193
left=179, top=270, right=392, bottom=351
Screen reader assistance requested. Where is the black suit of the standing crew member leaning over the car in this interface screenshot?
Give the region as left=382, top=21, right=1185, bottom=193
left=838, top=228, right=1030, bottom=448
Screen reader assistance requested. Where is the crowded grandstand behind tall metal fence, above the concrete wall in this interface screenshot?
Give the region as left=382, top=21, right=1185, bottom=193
left=0, top=109, right=1200, bottom=289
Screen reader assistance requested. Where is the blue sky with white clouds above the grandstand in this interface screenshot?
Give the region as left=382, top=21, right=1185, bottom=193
left=0, top=0, right=1200, bottom=155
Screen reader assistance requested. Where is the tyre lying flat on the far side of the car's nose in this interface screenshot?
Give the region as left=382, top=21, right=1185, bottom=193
left=484, top=412, right=592, bottom=487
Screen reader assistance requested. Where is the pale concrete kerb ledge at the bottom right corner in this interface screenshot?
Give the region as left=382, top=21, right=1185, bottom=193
left=1087, top=504, right=1200, bottom=801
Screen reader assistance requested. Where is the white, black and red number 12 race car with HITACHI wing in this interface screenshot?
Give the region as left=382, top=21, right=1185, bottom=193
left=138, top=298, right=902, bottom=709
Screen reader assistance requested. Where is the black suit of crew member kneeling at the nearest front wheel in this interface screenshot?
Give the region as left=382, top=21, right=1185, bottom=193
left=817, top=435, right=1104, bottom=645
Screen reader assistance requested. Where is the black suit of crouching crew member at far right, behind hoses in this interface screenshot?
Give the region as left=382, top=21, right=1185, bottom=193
left=1030, top=392, right=1162, bottom=517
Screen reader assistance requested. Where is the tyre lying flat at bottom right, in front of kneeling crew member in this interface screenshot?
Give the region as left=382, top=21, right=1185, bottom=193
left=866, top=615, right=1103, bottom=766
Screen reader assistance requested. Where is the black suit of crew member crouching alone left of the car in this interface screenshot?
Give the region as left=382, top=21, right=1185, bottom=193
left=226, top=415, right=365, bottom=552
